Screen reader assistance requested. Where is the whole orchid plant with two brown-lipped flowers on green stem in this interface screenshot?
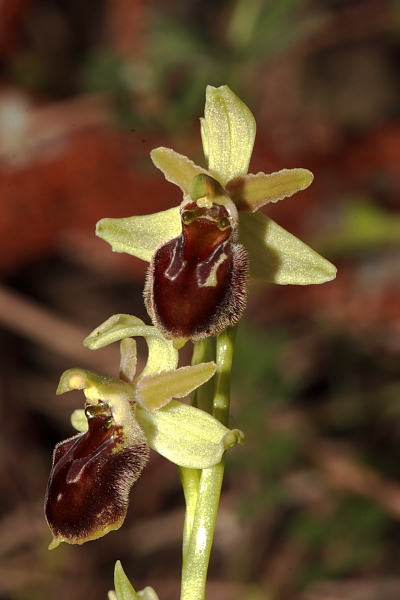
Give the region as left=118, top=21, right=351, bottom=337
left=45, top=86, right=336, bottom=600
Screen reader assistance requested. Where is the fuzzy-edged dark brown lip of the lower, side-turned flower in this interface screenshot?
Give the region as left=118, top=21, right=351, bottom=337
left=45, top=402, right=149, bottom=548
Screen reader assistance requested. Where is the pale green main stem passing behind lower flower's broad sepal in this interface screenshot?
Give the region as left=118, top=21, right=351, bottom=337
left=181, top=328, right=236, bottom=600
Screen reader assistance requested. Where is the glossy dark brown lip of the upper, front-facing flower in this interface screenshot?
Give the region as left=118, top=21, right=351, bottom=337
left=145, top=199, right=248, bottom=343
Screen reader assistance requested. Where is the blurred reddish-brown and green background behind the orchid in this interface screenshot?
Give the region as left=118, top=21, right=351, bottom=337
left=0, top=0, right=400, bottom=600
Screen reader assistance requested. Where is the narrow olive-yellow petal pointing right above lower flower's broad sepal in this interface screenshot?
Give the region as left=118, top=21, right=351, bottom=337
left=136, top=362, right=217, bottom=411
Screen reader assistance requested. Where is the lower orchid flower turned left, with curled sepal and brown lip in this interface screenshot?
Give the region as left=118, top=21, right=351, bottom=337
left=45, top=315, right=243, bottom=548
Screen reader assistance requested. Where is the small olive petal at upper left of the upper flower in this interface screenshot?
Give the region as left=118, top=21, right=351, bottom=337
left=150, top=147, right=209, bottom=195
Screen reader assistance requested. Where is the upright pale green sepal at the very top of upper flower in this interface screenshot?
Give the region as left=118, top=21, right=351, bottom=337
left=201, top=85, right=256, bottom=186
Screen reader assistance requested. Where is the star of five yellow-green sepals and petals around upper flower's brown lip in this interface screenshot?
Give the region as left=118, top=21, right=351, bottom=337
left=96, top=86, right=336, bottom=285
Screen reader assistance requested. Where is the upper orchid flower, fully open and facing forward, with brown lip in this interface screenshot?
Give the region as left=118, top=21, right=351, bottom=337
left=96, top=86, right=336, bottom=347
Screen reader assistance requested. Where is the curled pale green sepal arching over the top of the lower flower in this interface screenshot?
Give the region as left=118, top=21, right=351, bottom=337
left=83, top=315, right=179, bottom=377
